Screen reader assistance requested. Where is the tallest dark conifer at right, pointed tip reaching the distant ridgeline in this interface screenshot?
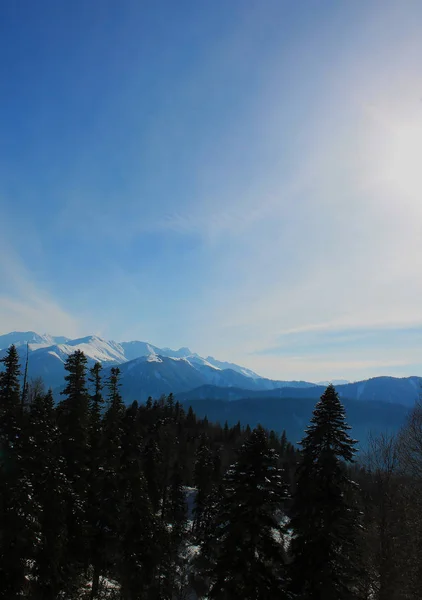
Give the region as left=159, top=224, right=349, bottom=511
left=291, top=385, right=359, bottom=600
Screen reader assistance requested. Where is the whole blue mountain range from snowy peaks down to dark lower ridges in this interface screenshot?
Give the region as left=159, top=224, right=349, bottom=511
left=0, top=331, right=422, bottom=448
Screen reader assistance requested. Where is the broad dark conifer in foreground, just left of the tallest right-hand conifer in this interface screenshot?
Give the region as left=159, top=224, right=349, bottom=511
left=203, top=427, right=287, bottom=600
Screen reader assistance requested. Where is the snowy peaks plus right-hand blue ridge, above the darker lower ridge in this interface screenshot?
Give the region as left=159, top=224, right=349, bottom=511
left=0, top=331, right=422, bottom=406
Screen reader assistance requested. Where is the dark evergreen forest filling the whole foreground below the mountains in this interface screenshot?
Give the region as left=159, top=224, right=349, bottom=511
left=0, top=346, right=422, bottom=600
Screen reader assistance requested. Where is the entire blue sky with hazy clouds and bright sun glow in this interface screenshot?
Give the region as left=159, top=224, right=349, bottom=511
left=0, top=0, right=422, bottom=380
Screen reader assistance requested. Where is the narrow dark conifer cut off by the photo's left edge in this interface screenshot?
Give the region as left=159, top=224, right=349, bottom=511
left=0, top=346, right=32, bottom=599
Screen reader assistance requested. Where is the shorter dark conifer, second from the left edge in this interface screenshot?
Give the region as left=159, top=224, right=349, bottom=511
left=26, top=390, right=68, bottom=600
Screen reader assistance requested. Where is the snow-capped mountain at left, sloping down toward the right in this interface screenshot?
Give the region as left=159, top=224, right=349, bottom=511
left=0, top=331, right=270, bottom=399
